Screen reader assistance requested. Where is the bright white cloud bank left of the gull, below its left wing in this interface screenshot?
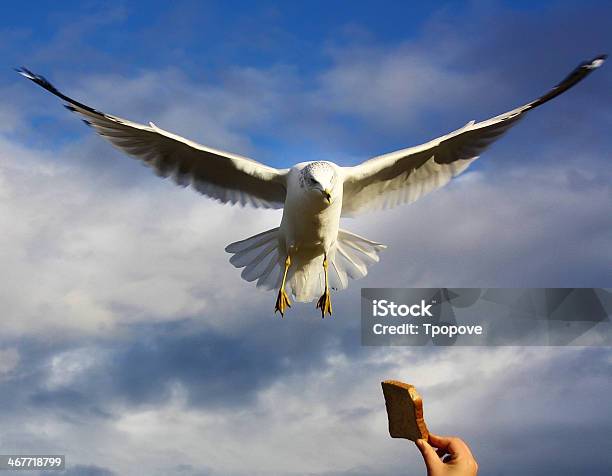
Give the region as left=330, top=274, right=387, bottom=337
left=0, top=132, right=277, bottom=334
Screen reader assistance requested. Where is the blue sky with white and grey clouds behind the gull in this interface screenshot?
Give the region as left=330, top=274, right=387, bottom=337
left=0, top=1, right=612, bottom=476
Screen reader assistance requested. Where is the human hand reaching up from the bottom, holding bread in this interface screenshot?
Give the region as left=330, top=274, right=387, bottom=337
left=416, top=433, right=478, bottom=476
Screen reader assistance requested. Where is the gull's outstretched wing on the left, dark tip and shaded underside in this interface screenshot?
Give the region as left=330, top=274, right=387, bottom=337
left=17, top=68, right=287, bottom=208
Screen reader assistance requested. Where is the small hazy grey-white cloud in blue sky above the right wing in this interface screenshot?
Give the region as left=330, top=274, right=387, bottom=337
left=316, top=43, right=492, bottom=128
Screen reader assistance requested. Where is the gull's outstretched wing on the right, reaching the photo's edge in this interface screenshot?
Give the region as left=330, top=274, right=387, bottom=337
left=342, top=55, right=606, bottom=216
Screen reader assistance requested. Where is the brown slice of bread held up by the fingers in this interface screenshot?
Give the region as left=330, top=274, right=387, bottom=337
left=382, top=380, right=429, bottom=441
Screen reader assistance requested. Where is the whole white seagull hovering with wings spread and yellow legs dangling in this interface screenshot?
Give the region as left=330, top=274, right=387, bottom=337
left=16, top=55, right=607, bottom=318
